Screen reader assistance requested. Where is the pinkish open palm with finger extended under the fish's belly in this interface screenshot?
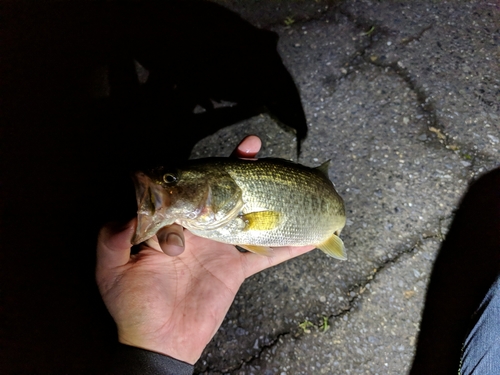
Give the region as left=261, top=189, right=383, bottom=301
left=101, top=230, right=313, bottom=363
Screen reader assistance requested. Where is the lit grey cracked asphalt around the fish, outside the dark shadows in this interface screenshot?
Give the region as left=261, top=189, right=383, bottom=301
left=192, top=0, right=500, bottom=375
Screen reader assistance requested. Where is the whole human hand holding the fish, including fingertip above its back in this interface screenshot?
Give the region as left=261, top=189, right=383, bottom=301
left=96, top=136, right=314, bottom=364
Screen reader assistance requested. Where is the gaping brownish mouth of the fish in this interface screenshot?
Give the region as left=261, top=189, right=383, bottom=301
left=132, top=172, right=172, bottom=245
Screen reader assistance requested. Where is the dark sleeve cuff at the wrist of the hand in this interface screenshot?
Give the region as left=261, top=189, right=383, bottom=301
left=109, top=344, right=194, bottom=375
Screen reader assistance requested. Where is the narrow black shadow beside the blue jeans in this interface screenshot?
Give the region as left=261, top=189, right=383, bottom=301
left=410, top=169, right=500, bottom=375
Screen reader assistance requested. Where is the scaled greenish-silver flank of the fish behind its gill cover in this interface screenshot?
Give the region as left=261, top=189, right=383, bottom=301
left=198, top=159, right=344, bottom=246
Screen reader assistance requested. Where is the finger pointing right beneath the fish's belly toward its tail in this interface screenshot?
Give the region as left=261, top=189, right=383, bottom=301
left=241, top=246, right=315, bottom=278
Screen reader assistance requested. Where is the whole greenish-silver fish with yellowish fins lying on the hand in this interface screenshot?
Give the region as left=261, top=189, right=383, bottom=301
left=133, top=158, right=346, bottom=260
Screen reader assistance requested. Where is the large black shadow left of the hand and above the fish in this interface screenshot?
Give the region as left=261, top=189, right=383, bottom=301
left=0, top=0, right=307, bottom=374
